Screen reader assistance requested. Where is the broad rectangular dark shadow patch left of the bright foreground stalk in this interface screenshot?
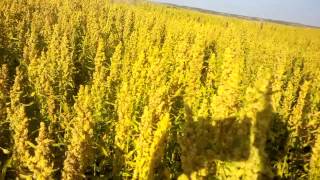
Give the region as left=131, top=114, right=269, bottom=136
left=179, top=105, right=252, bottom=175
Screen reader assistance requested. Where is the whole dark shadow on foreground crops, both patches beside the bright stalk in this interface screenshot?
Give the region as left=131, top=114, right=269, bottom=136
left=179, top=98, right=288, bottom=179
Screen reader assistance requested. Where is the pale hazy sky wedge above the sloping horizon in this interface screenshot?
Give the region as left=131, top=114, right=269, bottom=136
left=154, top=0, right=320, bottom=27
